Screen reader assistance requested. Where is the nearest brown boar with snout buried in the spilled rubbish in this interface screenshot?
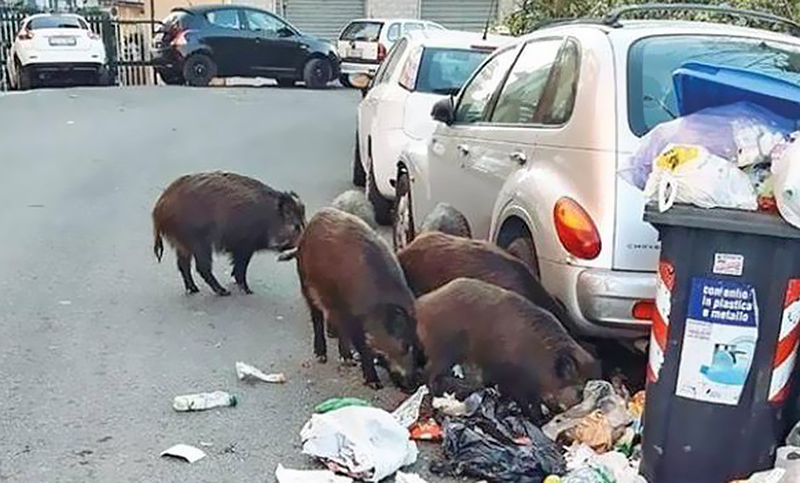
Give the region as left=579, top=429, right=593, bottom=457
left=416, top=278, right=600, bottom=419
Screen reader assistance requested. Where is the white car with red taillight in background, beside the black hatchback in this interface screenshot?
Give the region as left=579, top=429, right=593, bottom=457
left=336, top=18, right=445, bottom=87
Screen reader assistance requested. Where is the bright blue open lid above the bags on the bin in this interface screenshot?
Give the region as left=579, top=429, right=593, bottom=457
left=672, top=62, right=800, bottom=120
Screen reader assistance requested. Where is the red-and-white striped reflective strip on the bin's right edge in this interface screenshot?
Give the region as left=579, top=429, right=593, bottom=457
left=769, top=278, right=800, bottom=403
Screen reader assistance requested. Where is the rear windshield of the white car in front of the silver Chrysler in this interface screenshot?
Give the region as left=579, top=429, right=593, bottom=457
left=415, top=47, right=489, bottom=94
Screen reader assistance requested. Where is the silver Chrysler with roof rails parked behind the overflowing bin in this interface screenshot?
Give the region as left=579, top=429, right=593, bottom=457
left=393, top=6, right=800, bottom=337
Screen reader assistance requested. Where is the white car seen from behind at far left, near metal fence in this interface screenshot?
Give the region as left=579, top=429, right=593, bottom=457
left=6, top=14, right=110, bottom=90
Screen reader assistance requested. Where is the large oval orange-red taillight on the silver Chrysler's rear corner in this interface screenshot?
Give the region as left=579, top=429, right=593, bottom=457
left=553, top=197, right=602, bottom=260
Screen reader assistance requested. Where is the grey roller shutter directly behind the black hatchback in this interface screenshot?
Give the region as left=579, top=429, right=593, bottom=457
left=283, top=0, right=364, bottom=40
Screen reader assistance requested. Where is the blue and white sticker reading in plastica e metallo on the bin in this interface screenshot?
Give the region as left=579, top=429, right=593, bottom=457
left=675, top=277, right=758, bottom=406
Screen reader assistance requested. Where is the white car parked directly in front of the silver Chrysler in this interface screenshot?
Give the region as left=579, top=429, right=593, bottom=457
left=353, top=30, right=510, bottom=225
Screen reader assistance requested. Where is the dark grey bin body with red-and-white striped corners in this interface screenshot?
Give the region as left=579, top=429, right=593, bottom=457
left=641, top=204, right=800, bottom=483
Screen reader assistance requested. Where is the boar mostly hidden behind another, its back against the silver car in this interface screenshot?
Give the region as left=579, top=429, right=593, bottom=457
left=397, top=232, right=574, bottom=327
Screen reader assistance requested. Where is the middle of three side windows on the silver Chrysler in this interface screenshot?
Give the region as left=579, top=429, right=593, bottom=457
left=491, top=39, right=562, bottom=124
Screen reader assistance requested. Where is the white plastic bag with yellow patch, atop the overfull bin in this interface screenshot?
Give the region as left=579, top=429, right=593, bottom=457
left=644, top=144, right=758, bottom=212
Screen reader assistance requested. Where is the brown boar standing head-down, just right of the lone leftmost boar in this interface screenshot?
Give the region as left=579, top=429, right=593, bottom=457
left=296, top=208, right=418, bottom=390
